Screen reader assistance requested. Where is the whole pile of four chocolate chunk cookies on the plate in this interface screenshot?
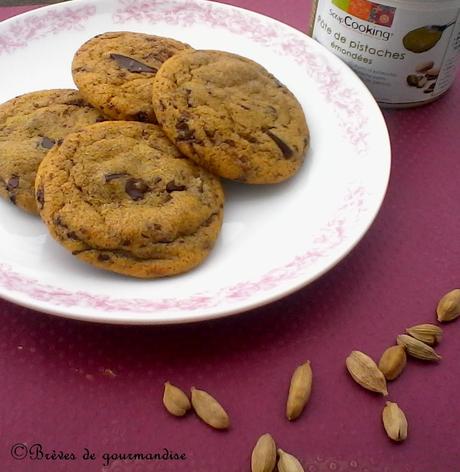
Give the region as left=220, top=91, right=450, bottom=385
left=0, top=32, right=309, bottom=278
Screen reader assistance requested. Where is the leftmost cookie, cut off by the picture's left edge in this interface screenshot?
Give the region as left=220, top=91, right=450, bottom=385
left=0, top=89, right=104, bottom=213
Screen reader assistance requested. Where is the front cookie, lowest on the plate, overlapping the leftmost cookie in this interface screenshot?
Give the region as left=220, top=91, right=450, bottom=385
left=36, top=121, right=224, bottom=278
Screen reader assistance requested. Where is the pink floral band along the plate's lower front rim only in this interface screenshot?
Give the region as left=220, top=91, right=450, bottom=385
left=0, top=185, right=368, bottom=313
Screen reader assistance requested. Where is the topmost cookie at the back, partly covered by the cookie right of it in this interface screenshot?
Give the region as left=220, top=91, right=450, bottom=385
left=72, top=32, right=190, bottom=123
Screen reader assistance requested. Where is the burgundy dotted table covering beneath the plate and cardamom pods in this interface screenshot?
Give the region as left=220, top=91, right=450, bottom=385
left=0, top=0, right=460, bottom=472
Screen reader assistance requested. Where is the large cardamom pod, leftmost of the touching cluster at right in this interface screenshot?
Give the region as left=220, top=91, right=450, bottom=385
left=346, top=351, right=388, bottom=395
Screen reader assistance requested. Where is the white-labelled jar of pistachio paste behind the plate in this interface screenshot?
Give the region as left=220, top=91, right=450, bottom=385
left=311, top=0, right=460, bottom=107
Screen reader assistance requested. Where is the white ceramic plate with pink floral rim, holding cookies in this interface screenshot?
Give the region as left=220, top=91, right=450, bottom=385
left=0, top=0, right=390, bottom=324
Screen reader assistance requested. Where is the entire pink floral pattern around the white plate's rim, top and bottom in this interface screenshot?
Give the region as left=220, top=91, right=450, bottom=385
left=0, top=0, right=380, bottom=313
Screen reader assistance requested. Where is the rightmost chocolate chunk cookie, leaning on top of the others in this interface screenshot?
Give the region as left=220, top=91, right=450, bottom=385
left=153, top=50, right=309, bottom=184
